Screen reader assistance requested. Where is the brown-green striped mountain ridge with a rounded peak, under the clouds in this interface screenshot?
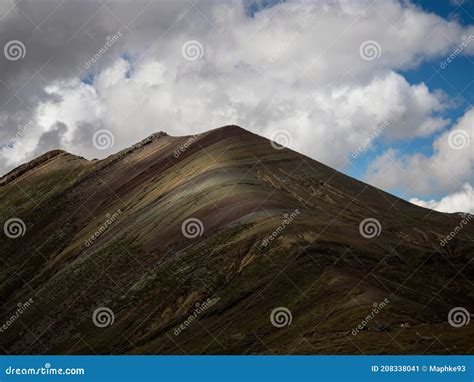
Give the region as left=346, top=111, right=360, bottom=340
left=0, top=126, right=474, bottom=354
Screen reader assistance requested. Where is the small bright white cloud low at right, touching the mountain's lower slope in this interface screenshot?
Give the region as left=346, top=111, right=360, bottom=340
left=410, top=183, right=474, bottom=214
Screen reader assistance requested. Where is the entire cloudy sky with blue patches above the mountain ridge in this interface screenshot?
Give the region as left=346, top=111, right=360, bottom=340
left=0, top=0, right=474, bottom=213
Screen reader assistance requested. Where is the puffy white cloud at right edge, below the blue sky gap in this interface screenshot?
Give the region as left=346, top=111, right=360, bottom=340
left=366, top=108, right=474, bottom=195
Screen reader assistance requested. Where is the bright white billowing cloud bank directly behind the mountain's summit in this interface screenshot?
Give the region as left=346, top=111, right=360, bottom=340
left=18, top=58, right=447, bottom=166
